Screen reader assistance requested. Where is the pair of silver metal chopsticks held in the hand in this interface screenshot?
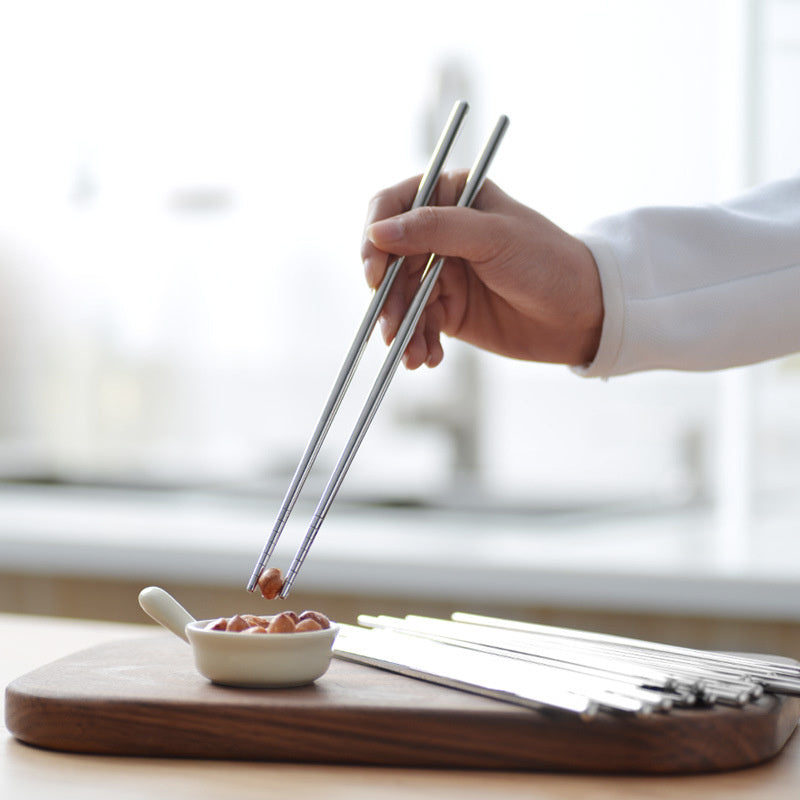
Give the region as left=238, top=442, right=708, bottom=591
left=247, top=101, right=509, bottom=598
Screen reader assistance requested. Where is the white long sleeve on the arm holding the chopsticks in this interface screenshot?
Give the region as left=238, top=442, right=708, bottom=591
left=575, top=175, right=800, bottom=377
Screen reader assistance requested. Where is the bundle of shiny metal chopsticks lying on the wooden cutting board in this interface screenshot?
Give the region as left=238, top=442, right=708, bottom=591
left=334, top=613, right=800, bottom=719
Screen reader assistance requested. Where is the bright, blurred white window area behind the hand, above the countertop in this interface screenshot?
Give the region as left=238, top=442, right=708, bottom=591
left=0, top=0, right=800, bottom=556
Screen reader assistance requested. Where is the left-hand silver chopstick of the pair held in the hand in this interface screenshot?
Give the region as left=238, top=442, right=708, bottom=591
left=247, top=100, right=469, bottom=592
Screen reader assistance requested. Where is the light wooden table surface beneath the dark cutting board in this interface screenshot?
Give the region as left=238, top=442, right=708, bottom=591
left=0, top=615, right=800, bottom=800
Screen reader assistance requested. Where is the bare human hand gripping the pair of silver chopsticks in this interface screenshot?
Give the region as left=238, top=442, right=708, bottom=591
left=361, top=171, right=603, bottom=369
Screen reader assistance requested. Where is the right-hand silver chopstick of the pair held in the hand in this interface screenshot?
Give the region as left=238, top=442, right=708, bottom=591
left=280, top=116, right=509, bottom=598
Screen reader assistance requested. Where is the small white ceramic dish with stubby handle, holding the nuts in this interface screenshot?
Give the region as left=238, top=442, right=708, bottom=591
left=139, top=586, right=339, bottom=689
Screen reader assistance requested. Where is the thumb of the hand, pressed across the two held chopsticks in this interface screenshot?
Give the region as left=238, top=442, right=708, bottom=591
left=366, top=206, right=495, bottom=261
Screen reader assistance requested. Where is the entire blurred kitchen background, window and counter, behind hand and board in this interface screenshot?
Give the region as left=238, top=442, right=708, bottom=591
left=0, top=0, right=800, bottom=655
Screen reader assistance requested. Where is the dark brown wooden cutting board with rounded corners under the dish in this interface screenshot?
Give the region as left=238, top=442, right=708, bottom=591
left=6, top=634, right=800, bottom=774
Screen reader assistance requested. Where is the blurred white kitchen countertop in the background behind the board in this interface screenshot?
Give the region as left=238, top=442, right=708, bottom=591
left=0, top=486, right=800, bottom=624
